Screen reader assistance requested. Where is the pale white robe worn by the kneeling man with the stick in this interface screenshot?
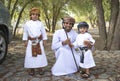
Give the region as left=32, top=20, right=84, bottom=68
left=51, top=29, right=80, bottom=76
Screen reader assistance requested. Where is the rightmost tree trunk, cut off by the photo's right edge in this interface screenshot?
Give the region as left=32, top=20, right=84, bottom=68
left=110, top=0, right=120, bottom=50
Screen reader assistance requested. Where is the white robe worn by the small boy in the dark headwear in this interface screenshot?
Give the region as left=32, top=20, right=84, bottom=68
left=73, top=32, right=95, bottom=68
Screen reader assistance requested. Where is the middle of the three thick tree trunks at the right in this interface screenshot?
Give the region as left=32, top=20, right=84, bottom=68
left=107, top=0, right=119, bottom=50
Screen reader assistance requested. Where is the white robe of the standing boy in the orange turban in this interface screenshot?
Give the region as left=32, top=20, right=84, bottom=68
left=23, top=20, right=48, bottom=68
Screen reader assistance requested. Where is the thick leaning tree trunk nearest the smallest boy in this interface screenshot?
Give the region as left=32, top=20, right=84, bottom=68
left=94, top=0, right=107, bottom=50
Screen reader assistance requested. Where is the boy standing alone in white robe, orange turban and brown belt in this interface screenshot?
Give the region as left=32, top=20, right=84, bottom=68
left=23, top=8, right=48, bottom=76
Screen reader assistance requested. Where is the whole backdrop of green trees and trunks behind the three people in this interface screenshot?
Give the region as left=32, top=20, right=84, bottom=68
left=0, top=0, right=120, bottom=50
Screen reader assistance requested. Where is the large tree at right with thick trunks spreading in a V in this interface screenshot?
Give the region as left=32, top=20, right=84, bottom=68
left=93, top=0, right=120, bottom=50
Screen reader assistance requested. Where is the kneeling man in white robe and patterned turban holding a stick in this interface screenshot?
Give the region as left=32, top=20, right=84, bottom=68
left=51, top=17, right=79, bottom=76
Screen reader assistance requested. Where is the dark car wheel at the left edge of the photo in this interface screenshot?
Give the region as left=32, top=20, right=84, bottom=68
left=0, top=31, right=8, bottom=64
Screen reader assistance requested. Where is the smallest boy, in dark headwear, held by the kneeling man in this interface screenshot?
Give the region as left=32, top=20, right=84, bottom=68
left=72, top=22, right=95, bottom=78
